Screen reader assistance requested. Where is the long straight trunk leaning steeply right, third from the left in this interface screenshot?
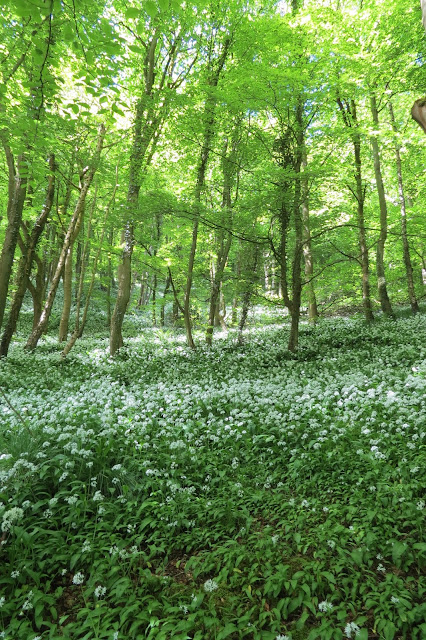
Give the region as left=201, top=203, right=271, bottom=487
left=25, top=125, right=105, bottom=350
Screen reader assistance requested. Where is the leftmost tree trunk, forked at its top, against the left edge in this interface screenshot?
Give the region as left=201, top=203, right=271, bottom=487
left=0, top=149, right=27, bottom=328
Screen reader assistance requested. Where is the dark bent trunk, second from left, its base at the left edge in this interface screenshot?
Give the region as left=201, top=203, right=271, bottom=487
left=0, top=154, right=55, bottom=357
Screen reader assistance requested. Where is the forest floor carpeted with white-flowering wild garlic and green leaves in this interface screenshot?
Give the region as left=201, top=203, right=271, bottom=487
left=0, top=314, right=426, bottom=640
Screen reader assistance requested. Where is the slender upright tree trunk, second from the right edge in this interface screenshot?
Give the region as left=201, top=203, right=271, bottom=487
left=370, top=94, right=393, bottom=316
